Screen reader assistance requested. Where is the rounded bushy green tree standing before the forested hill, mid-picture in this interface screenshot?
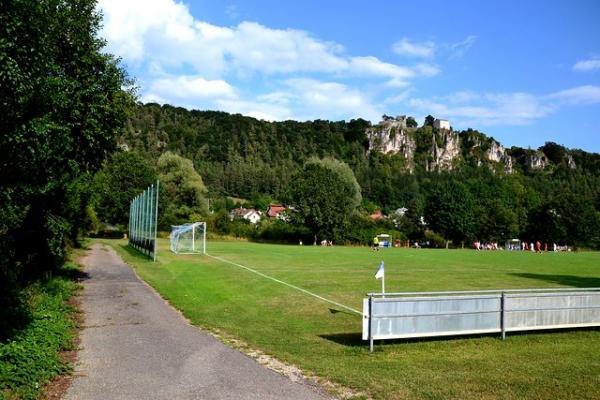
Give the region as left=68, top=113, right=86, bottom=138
left=290, top=158, right=362, bottom=240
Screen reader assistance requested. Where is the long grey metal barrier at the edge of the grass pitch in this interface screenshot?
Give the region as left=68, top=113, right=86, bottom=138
left=363, top=288, right=600, bottom=351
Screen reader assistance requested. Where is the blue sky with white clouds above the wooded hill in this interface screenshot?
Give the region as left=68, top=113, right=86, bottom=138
left=98, top=0, right=600, bottom=153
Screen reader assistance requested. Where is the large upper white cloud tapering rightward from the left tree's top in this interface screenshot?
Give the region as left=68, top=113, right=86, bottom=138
left=99, top=0, right=435, bottom=81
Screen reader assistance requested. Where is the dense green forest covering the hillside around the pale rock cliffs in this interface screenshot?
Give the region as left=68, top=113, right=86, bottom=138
left=112, top=104, right=600, bottom=248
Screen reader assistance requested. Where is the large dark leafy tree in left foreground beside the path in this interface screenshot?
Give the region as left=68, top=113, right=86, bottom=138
left=0, top=0, right=131, bottom=330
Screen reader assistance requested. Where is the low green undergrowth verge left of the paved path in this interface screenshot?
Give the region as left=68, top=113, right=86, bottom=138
left=0, top=263, right=79, bottom=400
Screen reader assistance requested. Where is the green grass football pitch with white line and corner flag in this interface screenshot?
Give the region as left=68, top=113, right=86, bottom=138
left=104, top=240, right=600, bottom=399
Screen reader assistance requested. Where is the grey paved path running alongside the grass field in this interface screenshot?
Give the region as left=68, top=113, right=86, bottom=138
left=66, top=244, right=327, bottom=400
